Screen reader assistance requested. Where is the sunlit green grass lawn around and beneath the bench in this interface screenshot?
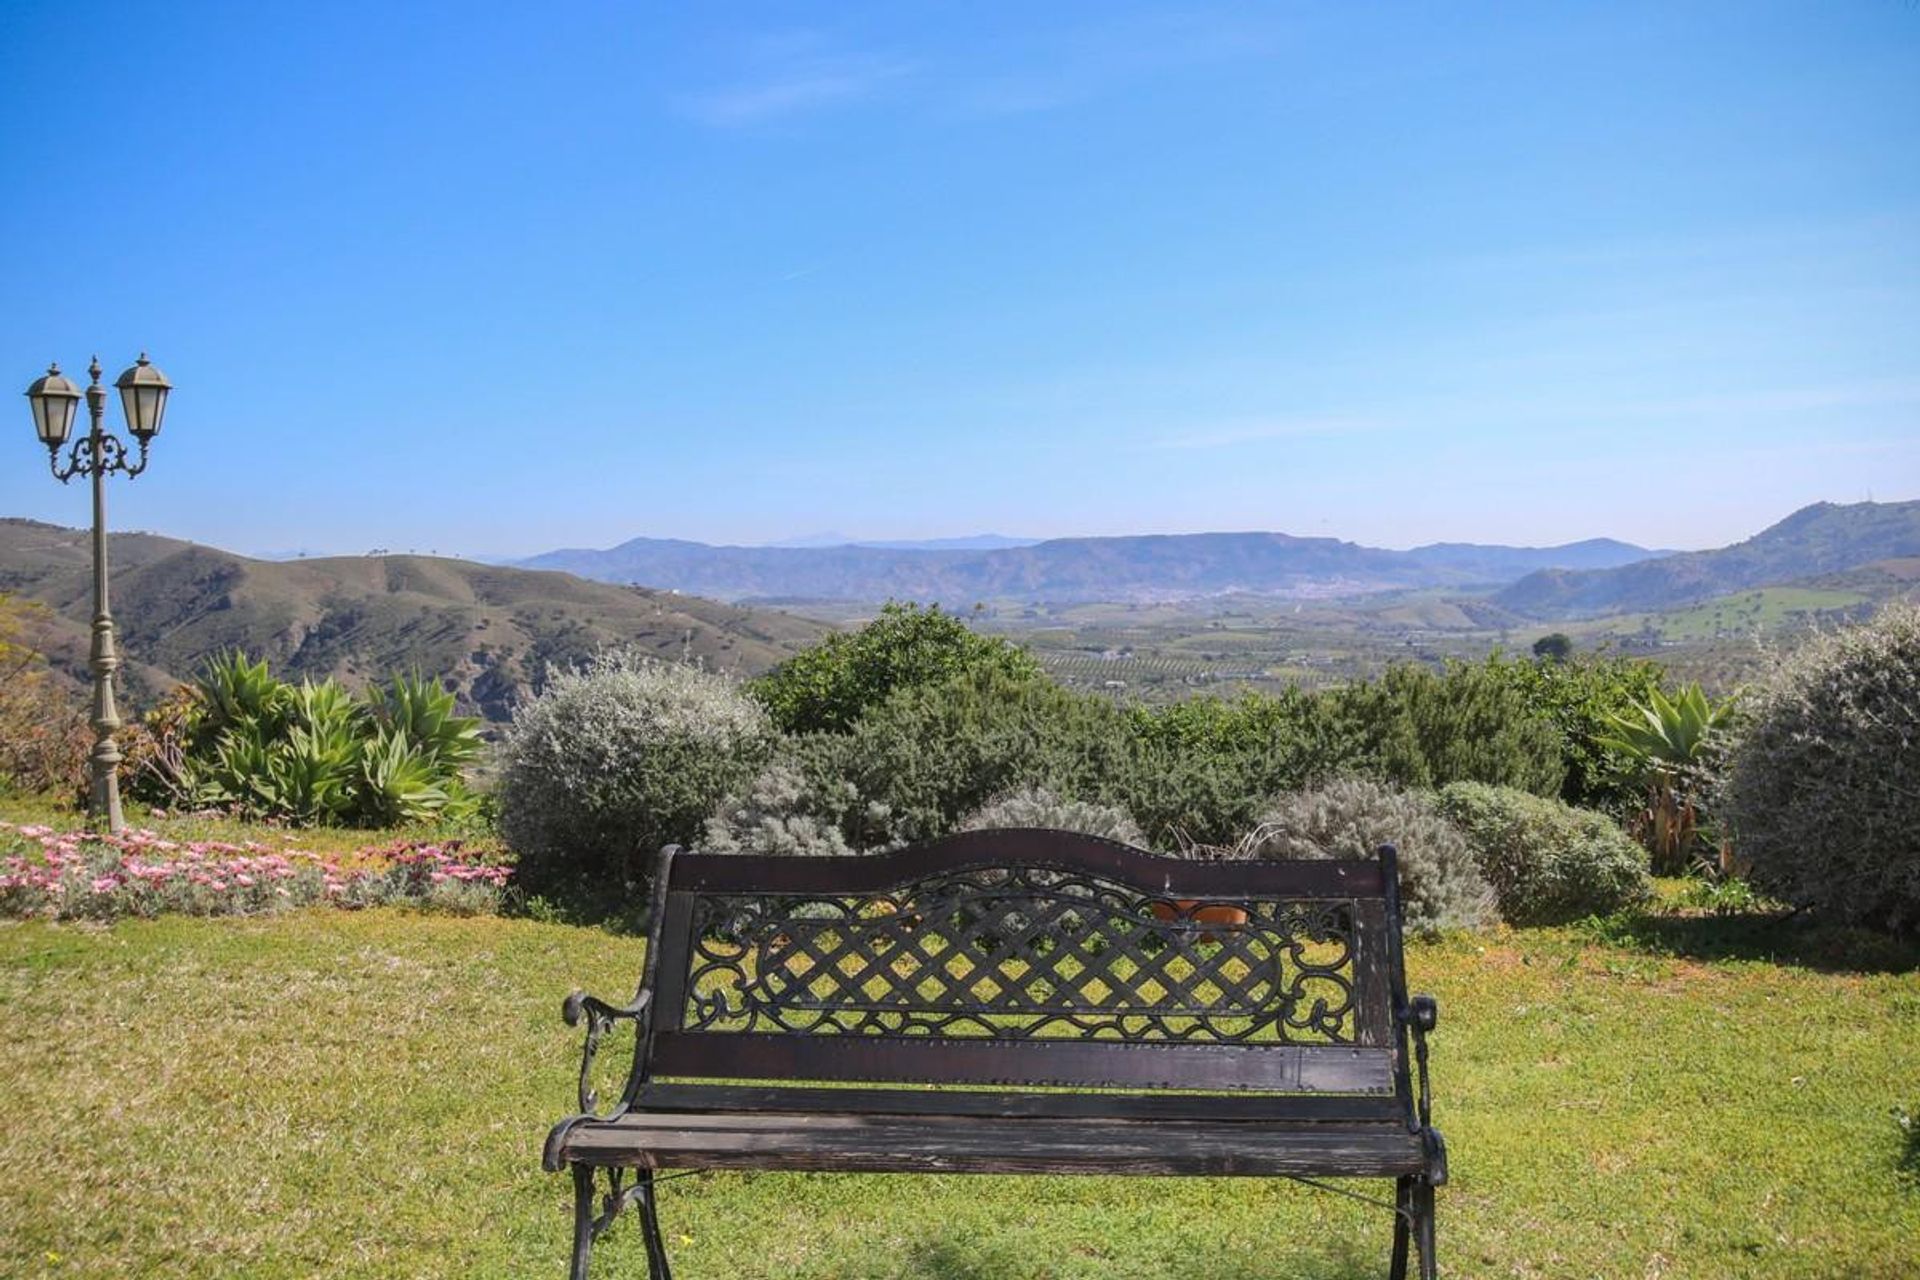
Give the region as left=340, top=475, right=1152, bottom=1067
left=0, top=910, right=1920, bottom=1280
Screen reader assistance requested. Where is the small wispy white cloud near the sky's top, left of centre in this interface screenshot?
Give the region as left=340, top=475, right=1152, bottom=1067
left=676, top=33, right=914, bottom=129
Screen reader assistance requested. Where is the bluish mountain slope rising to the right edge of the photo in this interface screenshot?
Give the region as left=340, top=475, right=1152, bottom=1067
left=1492, top=501, right=1920, bottom=620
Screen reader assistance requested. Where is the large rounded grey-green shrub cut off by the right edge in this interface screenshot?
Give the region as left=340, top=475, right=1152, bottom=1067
left=1716, top=604, right=1920, bottom=929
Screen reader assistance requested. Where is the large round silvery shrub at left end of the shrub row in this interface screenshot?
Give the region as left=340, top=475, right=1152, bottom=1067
left=497, top=651, right=774, bottom=892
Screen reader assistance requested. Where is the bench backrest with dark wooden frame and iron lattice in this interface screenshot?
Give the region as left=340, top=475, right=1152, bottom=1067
left=636, top=829, right=1409, bottom=1115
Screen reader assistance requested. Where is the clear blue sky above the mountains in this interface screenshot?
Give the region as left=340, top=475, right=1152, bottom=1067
left=0, top=0, right=1920, bottom=555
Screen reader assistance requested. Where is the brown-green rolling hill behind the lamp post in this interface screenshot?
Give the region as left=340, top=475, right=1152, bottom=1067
left=0, top=518, right=828, bottom=720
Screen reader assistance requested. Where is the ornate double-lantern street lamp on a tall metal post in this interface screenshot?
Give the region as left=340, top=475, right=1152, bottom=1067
left=27, top=351, right=173, bottom=835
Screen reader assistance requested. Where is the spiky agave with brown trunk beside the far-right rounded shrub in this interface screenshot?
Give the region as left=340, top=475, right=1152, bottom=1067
left=1597, top=683, right=1736, bottom=873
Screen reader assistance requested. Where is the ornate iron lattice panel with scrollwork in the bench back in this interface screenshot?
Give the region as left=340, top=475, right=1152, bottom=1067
left=682, top=865, right=1359, bottom=1044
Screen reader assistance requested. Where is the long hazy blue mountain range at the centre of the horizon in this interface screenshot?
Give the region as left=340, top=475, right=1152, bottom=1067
left=520, top=533, right=1661, bottom=608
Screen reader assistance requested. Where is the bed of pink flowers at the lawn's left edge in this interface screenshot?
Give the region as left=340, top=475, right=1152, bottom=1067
left=0, top=821, right=507, bottom=919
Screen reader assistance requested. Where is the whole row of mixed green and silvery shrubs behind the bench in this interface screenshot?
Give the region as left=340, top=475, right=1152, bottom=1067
left=501, top=610, right=1645, bottom=927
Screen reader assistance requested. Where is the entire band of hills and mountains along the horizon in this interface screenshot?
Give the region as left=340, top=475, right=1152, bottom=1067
left=0, top=501, right=1920, bottom=720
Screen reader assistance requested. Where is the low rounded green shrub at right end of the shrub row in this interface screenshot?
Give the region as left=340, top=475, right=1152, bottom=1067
left=1440, top=783, right=1651, bottom=925
